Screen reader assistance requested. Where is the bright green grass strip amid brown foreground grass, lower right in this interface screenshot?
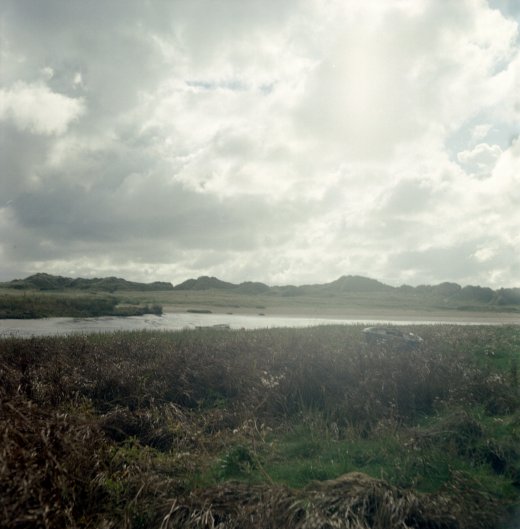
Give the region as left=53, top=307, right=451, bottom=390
left=205, top=412, right=520, bottom=501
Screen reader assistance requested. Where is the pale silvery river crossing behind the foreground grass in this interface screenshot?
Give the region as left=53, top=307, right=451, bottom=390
left=0, top=313, right=520, bottom=337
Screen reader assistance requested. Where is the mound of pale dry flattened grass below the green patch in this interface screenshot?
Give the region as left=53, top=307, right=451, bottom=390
left=161, top=472, right=460, bottom=529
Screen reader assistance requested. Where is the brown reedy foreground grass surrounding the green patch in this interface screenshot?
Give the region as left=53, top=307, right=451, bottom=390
left=0, top=326, right=518, bottom=529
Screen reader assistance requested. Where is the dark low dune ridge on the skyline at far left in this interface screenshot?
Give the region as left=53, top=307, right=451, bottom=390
left=1, top=274, right=173, bottom=292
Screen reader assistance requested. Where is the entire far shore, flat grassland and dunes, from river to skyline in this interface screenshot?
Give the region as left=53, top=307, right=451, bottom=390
left=0, top=273, right=520, bottom=322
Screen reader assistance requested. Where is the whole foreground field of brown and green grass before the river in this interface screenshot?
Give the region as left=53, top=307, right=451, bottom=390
left=0, top=326, right=520, bottom=528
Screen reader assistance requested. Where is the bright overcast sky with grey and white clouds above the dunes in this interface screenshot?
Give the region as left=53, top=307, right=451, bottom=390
left=0, top=0, right=520, bottom=288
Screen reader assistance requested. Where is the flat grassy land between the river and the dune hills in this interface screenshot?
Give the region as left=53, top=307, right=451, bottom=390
left=4, top=284, right=520, bottom=323
